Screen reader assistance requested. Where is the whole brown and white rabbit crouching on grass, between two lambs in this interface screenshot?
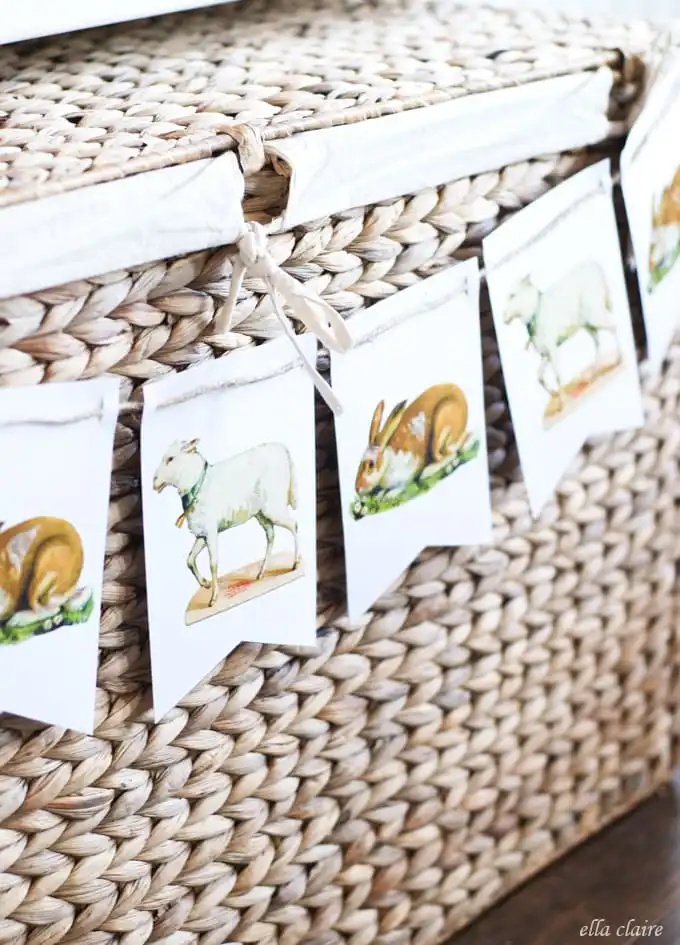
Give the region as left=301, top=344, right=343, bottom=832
left=355, top=384, right=468, bottom=494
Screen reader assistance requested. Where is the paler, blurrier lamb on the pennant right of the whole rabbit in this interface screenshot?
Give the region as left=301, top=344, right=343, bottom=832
left=504, top=262, right=620, bottom=406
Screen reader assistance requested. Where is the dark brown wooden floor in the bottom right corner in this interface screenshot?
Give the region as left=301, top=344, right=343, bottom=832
left=450, top=779, right=680, bottom=945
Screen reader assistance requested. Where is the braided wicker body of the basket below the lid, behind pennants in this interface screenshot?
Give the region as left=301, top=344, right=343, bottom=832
left=0, top=148, right=680, bottom=945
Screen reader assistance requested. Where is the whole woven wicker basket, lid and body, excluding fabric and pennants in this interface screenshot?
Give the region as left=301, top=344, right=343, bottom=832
left=0, top=0, right=680, bottom=945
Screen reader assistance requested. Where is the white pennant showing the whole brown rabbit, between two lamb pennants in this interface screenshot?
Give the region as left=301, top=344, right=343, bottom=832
left=331, top=260, right=492, bottom=619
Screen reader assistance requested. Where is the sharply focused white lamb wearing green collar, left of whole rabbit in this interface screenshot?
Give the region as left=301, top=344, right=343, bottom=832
left=153, top=440, right=299, bottom=607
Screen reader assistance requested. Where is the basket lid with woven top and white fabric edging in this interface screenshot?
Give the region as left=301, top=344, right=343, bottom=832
left=0, top=0, right=655, bottom=298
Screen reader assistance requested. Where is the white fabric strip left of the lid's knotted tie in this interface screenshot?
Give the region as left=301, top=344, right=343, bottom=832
left=0, top=153, right=245, bottom=299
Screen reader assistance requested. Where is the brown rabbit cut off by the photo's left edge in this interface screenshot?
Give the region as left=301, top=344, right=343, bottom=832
left=0, top=517, right=83, bottom=620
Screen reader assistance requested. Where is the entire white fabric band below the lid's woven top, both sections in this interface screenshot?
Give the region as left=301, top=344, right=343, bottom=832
left=0, top=68, right=616, bottom=299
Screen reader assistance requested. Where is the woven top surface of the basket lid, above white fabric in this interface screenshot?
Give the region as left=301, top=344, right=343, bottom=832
left=0, top=0, right=654, bottom=206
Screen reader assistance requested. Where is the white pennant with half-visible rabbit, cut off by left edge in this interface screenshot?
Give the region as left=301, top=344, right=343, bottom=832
left=0, top=378, right=119, bottom=734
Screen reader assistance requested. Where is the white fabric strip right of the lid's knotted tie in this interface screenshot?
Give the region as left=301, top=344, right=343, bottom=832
left=268, top=69, right=613, bottom=227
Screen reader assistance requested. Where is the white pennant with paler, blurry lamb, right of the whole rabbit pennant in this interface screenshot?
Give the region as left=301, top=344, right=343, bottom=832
left=484, top=161, right=643, bottom=515
